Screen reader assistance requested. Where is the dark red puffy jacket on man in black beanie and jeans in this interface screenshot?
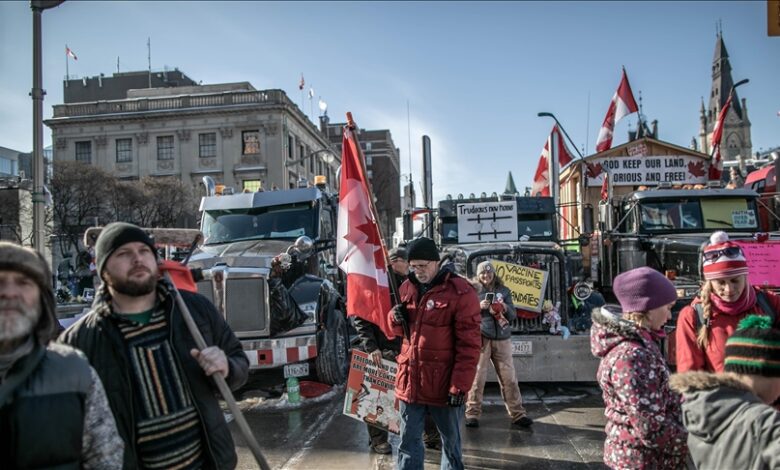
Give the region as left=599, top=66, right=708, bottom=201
left=388, top=265, right=481, bottom=406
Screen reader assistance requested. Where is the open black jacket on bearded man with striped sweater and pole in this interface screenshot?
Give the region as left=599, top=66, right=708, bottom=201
left=59, top=281, right=249, bottom=469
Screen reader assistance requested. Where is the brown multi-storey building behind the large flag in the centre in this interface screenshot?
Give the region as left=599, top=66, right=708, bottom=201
left=320, top=114, right=400, bottom=242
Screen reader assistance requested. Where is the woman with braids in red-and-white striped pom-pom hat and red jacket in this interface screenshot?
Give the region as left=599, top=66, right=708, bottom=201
left=675, top=232, right=780, bottom=372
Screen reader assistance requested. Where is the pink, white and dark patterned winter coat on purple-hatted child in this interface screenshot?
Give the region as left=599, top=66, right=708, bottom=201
left=590, top=307, right=687, bottom=469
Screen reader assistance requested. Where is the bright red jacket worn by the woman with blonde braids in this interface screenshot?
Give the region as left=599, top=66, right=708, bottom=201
left=675, top=287, right=780, bottom=372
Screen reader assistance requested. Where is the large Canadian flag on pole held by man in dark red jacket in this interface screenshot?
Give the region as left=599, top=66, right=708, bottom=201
left=336, top=128, right=395, bottom=338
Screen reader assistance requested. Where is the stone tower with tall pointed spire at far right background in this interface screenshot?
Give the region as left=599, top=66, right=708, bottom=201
left=695, top=32, right=753, bottom=162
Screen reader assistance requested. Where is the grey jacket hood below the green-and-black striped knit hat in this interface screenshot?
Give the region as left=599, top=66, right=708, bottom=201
left=669, top=371, right=761, bottom=442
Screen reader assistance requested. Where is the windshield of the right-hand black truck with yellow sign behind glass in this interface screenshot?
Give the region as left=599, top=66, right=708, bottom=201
left=637, top=198, right=758, bottom=231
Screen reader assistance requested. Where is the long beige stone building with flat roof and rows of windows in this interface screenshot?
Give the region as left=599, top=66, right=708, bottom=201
left=45, top=74, right=341, bottom=196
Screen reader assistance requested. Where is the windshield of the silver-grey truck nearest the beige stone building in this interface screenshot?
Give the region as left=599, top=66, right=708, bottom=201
left=202, top=202, right=318, bottom=245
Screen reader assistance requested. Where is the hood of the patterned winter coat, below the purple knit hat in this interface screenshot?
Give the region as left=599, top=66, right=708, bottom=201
left=590, top=305, right=650, bottom=357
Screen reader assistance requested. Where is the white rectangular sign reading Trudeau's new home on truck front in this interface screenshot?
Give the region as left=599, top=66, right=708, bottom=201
left=458, top=201, right=517, bottom=243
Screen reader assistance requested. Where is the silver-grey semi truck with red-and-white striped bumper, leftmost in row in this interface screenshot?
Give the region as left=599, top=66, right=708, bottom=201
left=189, top=181, right=349, bottom=384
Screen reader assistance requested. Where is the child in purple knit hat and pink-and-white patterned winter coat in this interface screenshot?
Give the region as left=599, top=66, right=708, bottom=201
left=590, top=267, right=688, bottom=469
